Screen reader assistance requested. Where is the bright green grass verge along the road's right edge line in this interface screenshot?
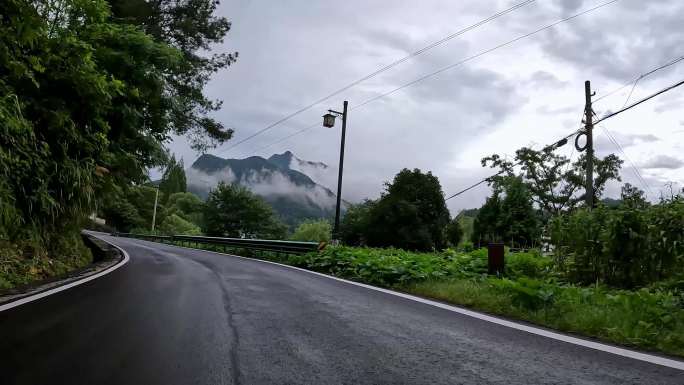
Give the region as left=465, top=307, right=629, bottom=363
left=404, top=278, right=684, bottom=357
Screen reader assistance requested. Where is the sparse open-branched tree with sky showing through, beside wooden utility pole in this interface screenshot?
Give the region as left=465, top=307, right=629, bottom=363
left=482, top=146, right=623, bottom=214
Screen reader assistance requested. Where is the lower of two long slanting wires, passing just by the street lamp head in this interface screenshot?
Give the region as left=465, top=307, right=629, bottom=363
left=246, top=0, right=620, bottom=156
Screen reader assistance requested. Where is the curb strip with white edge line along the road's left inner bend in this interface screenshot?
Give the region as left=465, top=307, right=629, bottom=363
left=0, top=231, right=130, bottom=312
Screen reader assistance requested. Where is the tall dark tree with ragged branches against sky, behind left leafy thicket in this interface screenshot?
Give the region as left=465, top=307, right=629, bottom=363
left=108, top=0, right=238, bottom=150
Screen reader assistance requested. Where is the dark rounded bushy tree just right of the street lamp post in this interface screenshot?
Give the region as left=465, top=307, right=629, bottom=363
left=366, top=169, right=449, bottom=250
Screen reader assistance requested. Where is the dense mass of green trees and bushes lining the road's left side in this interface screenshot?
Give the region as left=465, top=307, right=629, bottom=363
left=0, top=0, right=237, bottom=288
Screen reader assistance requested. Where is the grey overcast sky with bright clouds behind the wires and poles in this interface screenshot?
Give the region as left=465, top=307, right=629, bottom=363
left=162, top=0, right=684, bottom=211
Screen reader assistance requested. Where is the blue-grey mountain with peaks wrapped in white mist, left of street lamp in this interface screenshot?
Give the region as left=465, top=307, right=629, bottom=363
left=185, top=151, right=335, bottom=225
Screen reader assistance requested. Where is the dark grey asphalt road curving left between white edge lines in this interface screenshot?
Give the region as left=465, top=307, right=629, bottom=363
left=0, top=237, right=684, bottom=385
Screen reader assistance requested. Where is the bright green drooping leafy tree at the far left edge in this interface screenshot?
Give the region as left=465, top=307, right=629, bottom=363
left=0, top=0, right=118, bottom=237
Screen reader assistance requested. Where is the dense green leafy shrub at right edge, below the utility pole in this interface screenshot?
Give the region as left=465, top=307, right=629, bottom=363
left=550, top=197, right=684, bottom=288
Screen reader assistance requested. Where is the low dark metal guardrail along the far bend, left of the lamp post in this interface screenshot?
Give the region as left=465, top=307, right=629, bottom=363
left=112, top=233, right=325, bottom=254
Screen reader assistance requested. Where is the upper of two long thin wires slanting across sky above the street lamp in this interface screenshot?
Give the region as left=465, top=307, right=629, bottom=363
left=216, top=0, right=536, bottom=152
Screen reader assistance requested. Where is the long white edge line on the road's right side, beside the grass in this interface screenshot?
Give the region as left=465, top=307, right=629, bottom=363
left=147, top=241, right=684, bottom=370
